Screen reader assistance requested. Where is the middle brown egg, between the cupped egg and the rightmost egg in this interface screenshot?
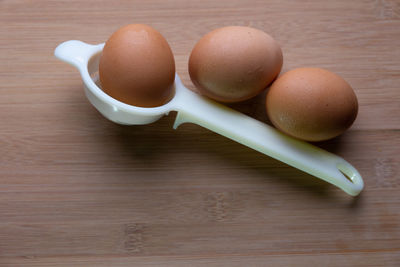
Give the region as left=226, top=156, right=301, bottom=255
left=189, top=26, right=283, bottom=102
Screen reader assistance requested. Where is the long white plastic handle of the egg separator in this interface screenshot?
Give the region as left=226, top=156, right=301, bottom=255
left=174, top=90, right=364, bottom=196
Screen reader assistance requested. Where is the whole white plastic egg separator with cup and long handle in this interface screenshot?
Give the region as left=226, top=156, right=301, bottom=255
left=54, top=40, right=364, bottom=196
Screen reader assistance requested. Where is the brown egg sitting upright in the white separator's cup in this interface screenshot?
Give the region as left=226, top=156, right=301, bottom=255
left=99, top=24, right=175, bottom=107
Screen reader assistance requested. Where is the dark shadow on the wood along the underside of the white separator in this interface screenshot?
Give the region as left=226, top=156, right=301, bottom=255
left=104, top=112, right=350, bottom=199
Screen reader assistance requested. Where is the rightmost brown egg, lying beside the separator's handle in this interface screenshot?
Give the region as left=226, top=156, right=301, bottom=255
left=266, top=68, right=358, bottom=141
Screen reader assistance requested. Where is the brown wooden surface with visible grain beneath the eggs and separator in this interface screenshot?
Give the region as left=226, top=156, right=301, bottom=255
left=0, top=0, right=400, bottom=266
